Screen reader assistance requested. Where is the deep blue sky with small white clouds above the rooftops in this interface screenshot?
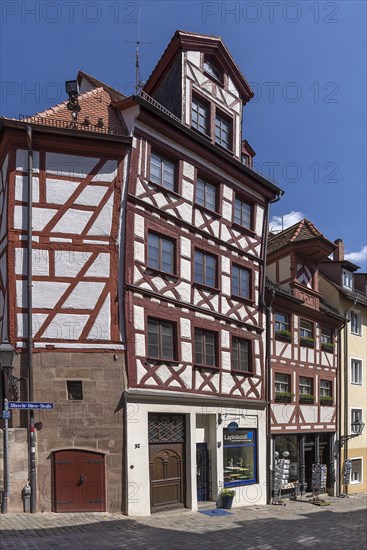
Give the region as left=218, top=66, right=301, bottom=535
left=0, top=0, right=367, bottom=270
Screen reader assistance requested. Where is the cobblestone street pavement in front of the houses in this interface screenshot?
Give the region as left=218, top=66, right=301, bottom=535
left=0, top=495, right=367, bottom=550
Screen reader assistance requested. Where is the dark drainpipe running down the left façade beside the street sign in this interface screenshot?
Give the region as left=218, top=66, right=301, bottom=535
left=26, top=124, right=37, bottom=514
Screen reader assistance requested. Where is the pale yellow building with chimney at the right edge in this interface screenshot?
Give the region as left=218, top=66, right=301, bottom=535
left=320, top=239, right=367, bottom=493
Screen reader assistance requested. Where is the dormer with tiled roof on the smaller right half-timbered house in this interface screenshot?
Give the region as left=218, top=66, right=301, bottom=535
left=267, top=219, right=335, bottom=309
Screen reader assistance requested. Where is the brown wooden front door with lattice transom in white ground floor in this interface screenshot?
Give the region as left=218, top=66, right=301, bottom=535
left=149, top=415, right=185, bottom=512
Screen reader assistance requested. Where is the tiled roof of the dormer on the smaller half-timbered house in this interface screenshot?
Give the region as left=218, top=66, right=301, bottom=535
left=268, top=218, right=335, bottom=254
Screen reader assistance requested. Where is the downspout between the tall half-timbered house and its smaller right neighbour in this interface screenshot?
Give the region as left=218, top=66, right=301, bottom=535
left=259, top=191, right=284, bottom=504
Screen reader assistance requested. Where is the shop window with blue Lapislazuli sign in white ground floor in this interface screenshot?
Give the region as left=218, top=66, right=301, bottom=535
left=223, top=428, right=257, bottom=487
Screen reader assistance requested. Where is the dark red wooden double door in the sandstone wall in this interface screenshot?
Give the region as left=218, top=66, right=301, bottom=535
left=53, top=450, right=106, bottom=512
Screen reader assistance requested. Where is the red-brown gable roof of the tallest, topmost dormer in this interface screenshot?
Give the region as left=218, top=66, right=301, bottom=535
left=144, top=30, right=254, bottom=102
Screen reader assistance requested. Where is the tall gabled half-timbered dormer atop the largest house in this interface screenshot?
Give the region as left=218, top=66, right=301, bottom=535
left=144, top=31, right=253, bottom=161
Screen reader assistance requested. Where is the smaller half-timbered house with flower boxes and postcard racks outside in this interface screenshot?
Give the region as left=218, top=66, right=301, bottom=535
left=267, top=219, right=343, bottom=500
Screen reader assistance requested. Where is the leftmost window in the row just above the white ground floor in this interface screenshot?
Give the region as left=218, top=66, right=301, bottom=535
left=148, top=318, right=177, bottom=361
